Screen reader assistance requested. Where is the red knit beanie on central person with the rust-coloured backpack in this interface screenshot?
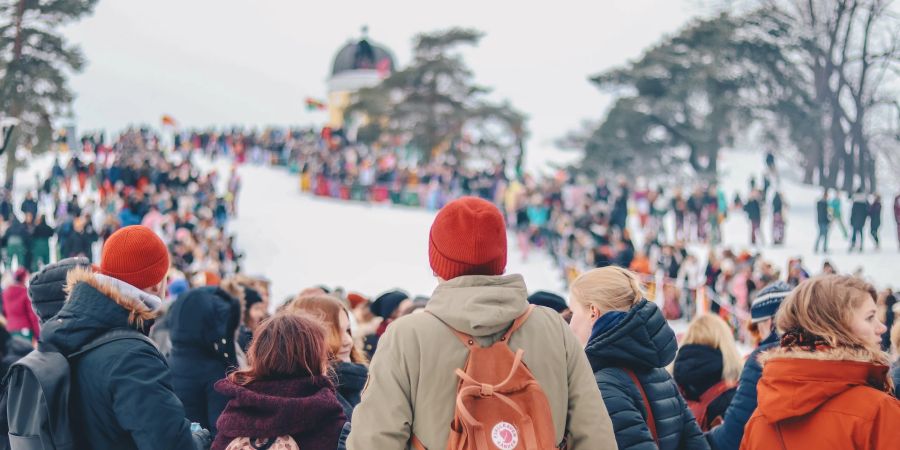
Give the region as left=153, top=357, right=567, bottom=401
left=428, top=197, right=506, bottom=280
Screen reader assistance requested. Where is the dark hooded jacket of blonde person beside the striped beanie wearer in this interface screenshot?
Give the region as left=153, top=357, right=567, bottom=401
left=673, top=344, right=736, bottom=430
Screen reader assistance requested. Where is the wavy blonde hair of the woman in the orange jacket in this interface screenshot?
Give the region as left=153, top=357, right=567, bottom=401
left=775, top=275, right=884, bottom=361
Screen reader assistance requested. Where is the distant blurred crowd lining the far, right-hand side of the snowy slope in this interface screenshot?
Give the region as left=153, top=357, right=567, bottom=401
left=199, top=130, right=900, bottom=342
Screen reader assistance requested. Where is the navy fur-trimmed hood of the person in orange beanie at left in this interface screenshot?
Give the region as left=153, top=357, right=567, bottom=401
left=41, top=267, right=161, bottom=356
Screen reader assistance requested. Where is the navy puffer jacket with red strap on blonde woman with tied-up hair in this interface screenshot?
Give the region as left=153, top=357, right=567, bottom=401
left=585, top=300, right=709, bottom=450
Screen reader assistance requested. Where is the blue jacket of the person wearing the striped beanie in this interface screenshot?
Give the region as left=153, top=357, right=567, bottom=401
left=706, top=333, right=779, bottom=450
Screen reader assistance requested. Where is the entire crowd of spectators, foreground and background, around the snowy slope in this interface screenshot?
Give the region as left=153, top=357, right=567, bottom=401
left=0, top=131, right=900, bottom=450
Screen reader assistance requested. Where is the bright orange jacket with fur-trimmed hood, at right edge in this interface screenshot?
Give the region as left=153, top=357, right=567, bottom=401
left=741, top=348, right=900, bottom=450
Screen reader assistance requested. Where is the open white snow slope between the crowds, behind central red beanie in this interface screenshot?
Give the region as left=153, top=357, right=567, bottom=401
left=232, top=165, right=563, bottom=304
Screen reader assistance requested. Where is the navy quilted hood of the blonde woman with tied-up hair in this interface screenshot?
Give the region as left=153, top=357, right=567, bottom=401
left=584, top=299, right=678, bottom=372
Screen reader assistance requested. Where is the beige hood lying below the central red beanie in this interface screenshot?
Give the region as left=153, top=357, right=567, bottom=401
left=425, top=275, right=528, bottom=336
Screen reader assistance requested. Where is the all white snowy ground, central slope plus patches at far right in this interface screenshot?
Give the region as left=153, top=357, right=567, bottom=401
left=233, top=151, right=900, bottom=304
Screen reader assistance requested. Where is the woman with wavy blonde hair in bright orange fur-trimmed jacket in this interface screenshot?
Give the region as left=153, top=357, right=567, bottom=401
left=741, top=275, right=900, bottom=450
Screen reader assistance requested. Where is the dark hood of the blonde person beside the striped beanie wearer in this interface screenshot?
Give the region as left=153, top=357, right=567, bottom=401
left=672, top=344, right=724, bottom=401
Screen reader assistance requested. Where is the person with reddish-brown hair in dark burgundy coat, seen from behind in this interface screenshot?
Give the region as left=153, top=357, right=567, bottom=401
left=211, top=313, right=348, bottom=450
